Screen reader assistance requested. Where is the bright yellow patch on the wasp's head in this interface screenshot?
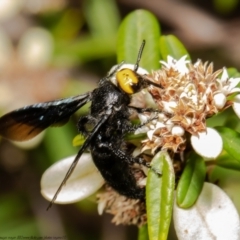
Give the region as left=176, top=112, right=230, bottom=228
left=116, top=68, right=139, bottom=94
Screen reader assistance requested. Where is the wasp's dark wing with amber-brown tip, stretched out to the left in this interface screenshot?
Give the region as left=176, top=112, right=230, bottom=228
left=0, top=92, right=91, bottom=141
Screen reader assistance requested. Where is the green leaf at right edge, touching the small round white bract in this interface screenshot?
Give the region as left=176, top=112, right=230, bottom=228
left=215, top=127, right=240, bottom=161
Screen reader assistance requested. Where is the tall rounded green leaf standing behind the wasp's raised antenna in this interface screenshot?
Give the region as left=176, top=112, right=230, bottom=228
left=117, top=10, right=160, bottom=71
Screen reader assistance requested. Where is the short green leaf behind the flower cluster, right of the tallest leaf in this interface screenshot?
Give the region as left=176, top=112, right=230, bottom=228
left=160, top=35, right=191, bottom=61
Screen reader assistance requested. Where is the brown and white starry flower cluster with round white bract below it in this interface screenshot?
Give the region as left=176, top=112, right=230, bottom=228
left=143, top=56, right=240, bottom=159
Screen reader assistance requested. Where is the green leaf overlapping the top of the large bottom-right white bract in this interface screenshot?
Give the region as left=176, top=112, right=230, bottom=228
left=176, top=153, right=206, bottom=208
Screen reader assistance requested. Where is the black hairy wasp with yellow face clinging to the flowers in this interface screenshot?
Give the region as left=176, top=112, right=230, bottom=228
left=0, top=41, right=159, bottom=207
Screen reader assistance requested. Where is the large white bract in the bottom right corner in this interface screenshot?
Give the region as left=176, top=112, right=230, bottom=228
left=173, top=183, right=240, bottom=240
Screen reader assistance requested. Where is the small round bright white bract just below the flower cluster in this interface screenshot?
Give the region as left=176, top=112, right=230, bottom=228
left=191, top=128, right=223, bottom=159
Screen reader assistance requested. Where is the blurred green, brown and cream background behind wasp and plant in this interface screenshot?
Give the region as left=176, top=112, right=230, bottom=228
left=0, top=0, right=240, bottom=240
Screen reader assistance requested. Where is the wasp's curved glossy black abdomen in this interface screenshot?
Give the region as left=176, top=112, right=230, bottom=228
left=91, top=139, right=145, bottom=199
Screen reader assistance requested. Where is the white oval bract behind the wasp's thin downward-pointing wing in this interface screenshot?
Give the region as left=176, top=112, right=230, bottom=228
left=41, top=153, right=104, bottom=204
